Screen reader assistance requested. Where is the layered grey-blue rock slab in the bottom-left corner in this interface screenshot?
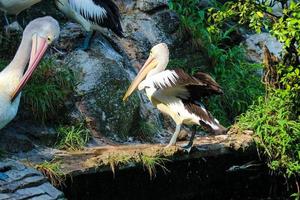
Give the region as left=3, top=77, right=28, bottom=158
left=0, top=160, right=64, bottom=200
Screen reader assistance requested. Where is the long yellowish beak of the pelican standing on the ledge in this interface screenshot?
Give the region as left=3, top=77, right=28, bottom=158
left=123, top=55, right=157, bottom=101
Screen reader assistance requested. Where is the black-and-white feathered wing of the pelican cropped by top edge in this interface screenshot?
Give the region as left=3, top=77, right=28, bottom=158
left=69, top=0, right=123, bottom=37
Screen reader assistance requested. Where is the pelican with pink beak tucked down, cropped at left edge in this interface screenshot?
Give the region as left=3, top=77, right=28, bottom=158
left=0, top=17, right=60, bottom=129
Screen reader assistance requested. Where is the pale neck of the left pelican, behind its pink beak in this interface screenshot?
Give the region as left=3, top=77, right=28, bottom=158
left=3, top=37, right=31, bottom=79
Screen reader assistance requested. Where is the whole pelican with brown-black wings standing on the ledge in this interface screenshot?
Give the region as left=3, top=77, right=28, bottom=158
left=123, top=43, right=226, bottom=152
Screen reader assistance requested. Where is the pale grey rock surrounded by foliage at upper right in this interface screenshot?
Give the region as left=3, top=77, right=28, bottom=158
left=245, top=33, right=283, bottom=63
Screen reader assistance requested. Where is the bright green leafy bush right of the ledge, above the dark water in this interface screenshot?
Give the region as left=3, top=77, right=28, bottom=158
left=238, top=90, right=300, bottom=177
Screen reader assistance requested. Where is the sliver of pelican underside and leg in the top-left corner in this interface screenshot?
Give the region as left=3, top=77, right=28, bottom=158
left=0, top=0, right=41, bottom=25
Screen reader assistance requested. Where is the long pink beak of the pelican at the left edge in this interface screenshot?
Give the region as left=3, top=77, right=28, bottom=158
left=11, top=34, right=49, bottom=102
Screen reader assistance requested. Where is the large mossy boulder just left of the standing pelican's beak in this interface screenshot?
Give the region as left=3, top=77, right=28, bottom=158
left=66, top=38, right=139, bottom=140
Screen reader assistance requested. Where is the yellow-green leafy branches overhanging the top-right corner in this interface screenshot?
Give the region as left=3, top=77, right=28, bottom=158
left=209, top=0, right=300, bottom=112
